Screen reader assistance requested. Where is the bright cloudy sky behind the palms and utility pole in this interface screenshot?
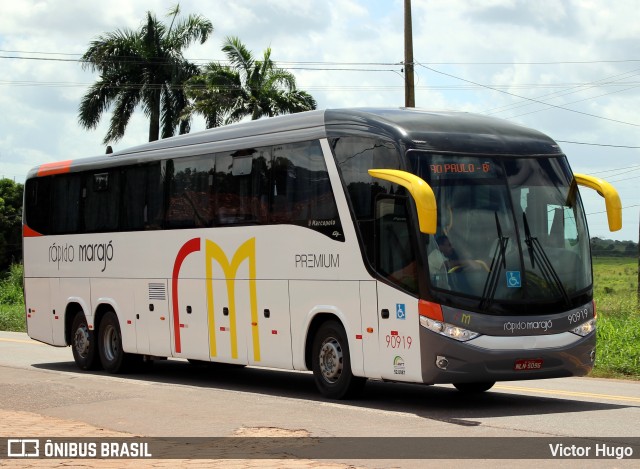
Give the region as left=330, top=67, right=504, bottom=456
left=0, top=0, right=640, bottom=240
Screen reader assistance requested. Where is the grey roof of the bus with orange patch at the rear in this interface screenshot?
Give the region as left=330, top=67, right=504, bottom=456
left=27, top=108, right=561, bottom=179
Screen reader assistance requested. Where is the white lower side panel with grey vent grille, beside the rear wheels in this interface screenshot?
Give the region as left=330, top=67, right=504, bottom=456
left=134, top=279, right=171, bottom=357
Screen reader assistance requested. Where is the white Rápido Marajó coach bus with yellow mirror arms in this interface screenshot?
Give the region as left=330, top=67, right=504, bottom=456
left=23, top=109, right=621, bottom=398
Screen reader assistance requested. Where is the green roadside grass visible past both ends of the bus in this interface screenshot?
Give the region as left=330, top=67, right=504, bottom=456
left=0, top=257, right=640, bottom=380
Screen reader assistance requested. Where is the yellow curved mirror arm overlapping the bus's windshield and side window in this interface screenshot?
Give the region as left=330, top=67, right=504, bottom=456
left=369, top=169, right=438, bottom=234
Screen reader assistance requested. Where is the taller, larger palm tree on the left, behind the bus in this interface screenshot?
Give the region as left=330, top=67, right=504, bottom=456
left=79, top=5, right=213, bottom=144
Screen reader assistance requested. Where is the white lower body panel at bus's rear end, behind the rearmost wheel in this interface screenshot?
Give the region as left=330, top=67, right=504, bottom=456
left=25, top=278, right=53, bottom=344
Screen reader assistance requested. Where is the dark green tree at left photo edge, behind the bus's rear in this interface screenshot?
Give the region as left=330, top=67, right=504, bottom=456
left=0, top=178, right=24, bottom=272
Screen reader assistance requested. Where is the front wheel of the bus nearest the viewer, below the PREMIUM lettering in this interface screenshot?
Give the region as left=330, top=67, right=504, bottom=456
left=311, top=321, right=366, bottom=399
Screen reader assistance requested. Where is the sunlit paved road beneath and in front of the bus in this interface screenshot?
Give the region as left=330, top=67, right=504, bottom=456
left=0, top=332, right=640, bottom=468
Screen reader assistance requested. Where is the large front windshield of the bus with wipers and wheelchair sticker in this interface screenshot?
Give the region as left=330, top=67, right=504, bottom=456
left=408, top=151, right=592, bottom=312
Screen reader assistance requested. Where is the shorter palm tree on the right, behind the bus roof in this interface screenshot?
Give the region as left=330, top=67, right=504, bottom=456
left=185, top=37, right=317, bottom=127
